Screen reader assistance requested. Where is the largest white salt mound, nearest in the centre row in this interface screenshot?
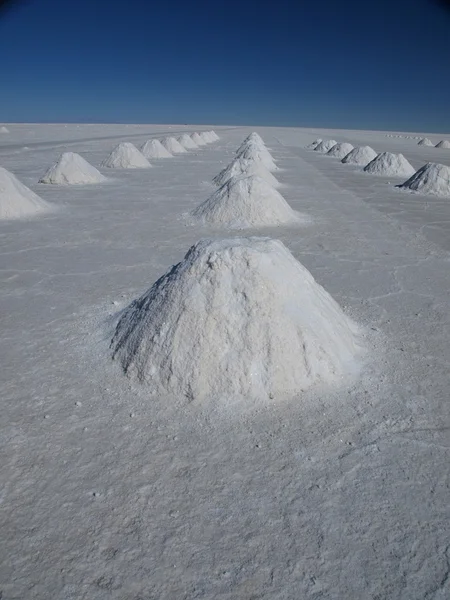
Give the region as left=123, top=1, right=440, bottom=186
left=111, top=237, right=361, bottom=402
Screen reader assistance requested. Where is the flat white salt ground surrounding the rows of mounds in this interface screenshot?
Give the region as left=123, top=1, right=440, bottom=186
left=0, top=125, right=450, bottom=600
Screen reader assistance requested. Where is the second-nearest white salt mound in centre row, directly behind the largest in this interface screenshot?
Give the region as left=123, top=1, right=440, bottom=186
left=192, top=175, right=307, bottom=229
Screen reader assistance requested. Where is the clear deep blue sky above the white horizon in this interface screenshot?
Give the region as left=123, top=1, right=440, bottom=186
left=0, top=0, right=450, bottom=132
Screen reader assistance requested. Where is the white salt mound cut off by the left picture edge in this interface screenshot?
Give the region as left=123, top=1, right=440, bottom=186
left=0, top=167, right=51, bottom=219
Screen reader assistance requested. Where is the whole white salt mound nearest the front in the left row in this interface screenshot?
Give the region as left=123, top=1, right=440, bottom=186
left=39, top=152, right=106, bottom=185
